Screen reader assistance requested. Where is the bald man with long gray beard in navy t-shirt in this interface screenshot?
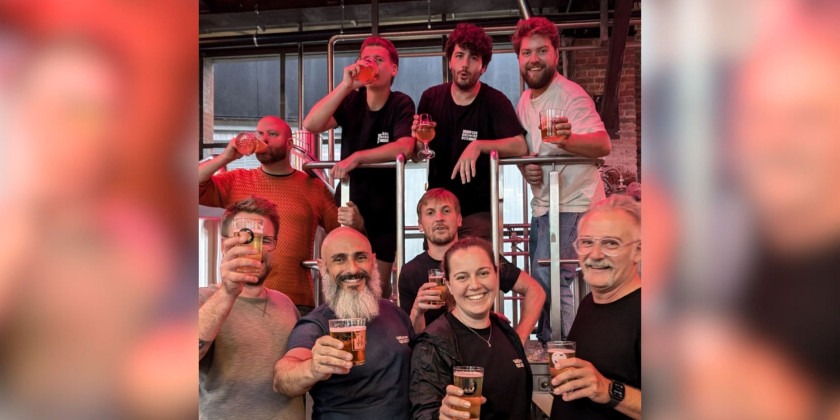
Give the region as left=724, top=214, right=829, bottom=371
left=274, top=227, right=414, bottom=419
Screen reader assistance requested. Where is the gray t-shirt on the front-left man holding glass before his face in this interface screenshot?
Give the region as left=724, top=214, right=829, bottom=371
left=198, top=286, right=305, bottom=420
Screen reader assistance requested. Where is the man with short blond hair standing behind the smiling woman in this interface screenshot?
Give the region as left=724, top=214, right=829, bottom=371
left=397, top=188, right=545, bottom=343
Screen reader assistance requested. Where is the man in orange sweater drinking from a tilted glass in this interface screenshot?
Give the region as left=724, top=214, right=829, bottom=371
left=203, top=116, right=364, bottom=315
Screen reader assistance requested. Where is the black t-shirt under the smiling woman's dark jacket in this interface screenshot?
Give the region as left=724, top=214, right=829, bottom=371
left=452, top=316, right=531, bottom=420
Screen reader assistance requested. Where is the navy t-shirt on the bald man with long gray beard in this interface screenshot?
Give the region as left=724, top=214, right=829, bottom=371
left=289, top=299, right=414, bottom=420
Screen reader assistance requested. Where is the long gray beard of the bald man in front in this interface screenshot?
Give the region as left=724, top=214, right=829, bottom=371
left=321, top=268, right=382, bottom=322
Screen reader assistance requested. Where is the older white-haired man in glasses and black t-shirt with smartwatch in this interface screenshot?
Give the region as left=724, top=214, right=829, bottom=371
left=551, top=195, right=642, bottom=419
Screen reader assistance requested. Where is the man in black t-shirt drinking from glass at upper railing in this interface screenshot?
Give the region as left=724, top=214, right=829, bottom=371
left=303, top=36, right=414, bottom=299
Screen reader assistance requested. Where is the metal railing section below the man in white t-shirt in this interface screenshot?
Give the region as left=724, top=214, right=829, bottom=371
left=490, top=154, right=604, bottom=340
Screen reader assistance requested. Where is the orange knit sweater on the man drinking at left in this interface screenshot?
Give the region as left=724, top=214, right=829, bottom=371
left=198, top=168, right=338, bottom=306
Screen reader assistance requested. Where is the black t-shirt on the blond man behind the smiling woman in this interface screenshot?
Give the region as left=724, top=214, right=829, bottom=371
left=399, top=252, right=522, bottom=325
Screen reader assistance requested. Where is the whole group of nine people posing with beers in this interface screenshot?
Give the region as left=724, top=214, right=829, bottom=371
left=199, top=17, right=641, bottom=419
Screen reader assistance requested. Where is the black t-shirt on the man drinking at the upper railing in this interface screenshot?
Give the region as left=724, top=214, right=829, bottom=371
left=333, top=87, right=414, bottom=233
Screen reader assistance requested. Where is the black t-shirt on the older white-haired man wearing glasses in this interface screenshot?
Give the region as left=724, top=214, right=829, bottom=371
left=551, top=289, right=642, bottom=420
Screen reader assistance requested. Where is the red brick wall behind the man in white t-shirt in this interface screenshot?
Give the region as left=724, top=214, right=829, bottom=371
left=565, top=27, right=642, bottom=182
